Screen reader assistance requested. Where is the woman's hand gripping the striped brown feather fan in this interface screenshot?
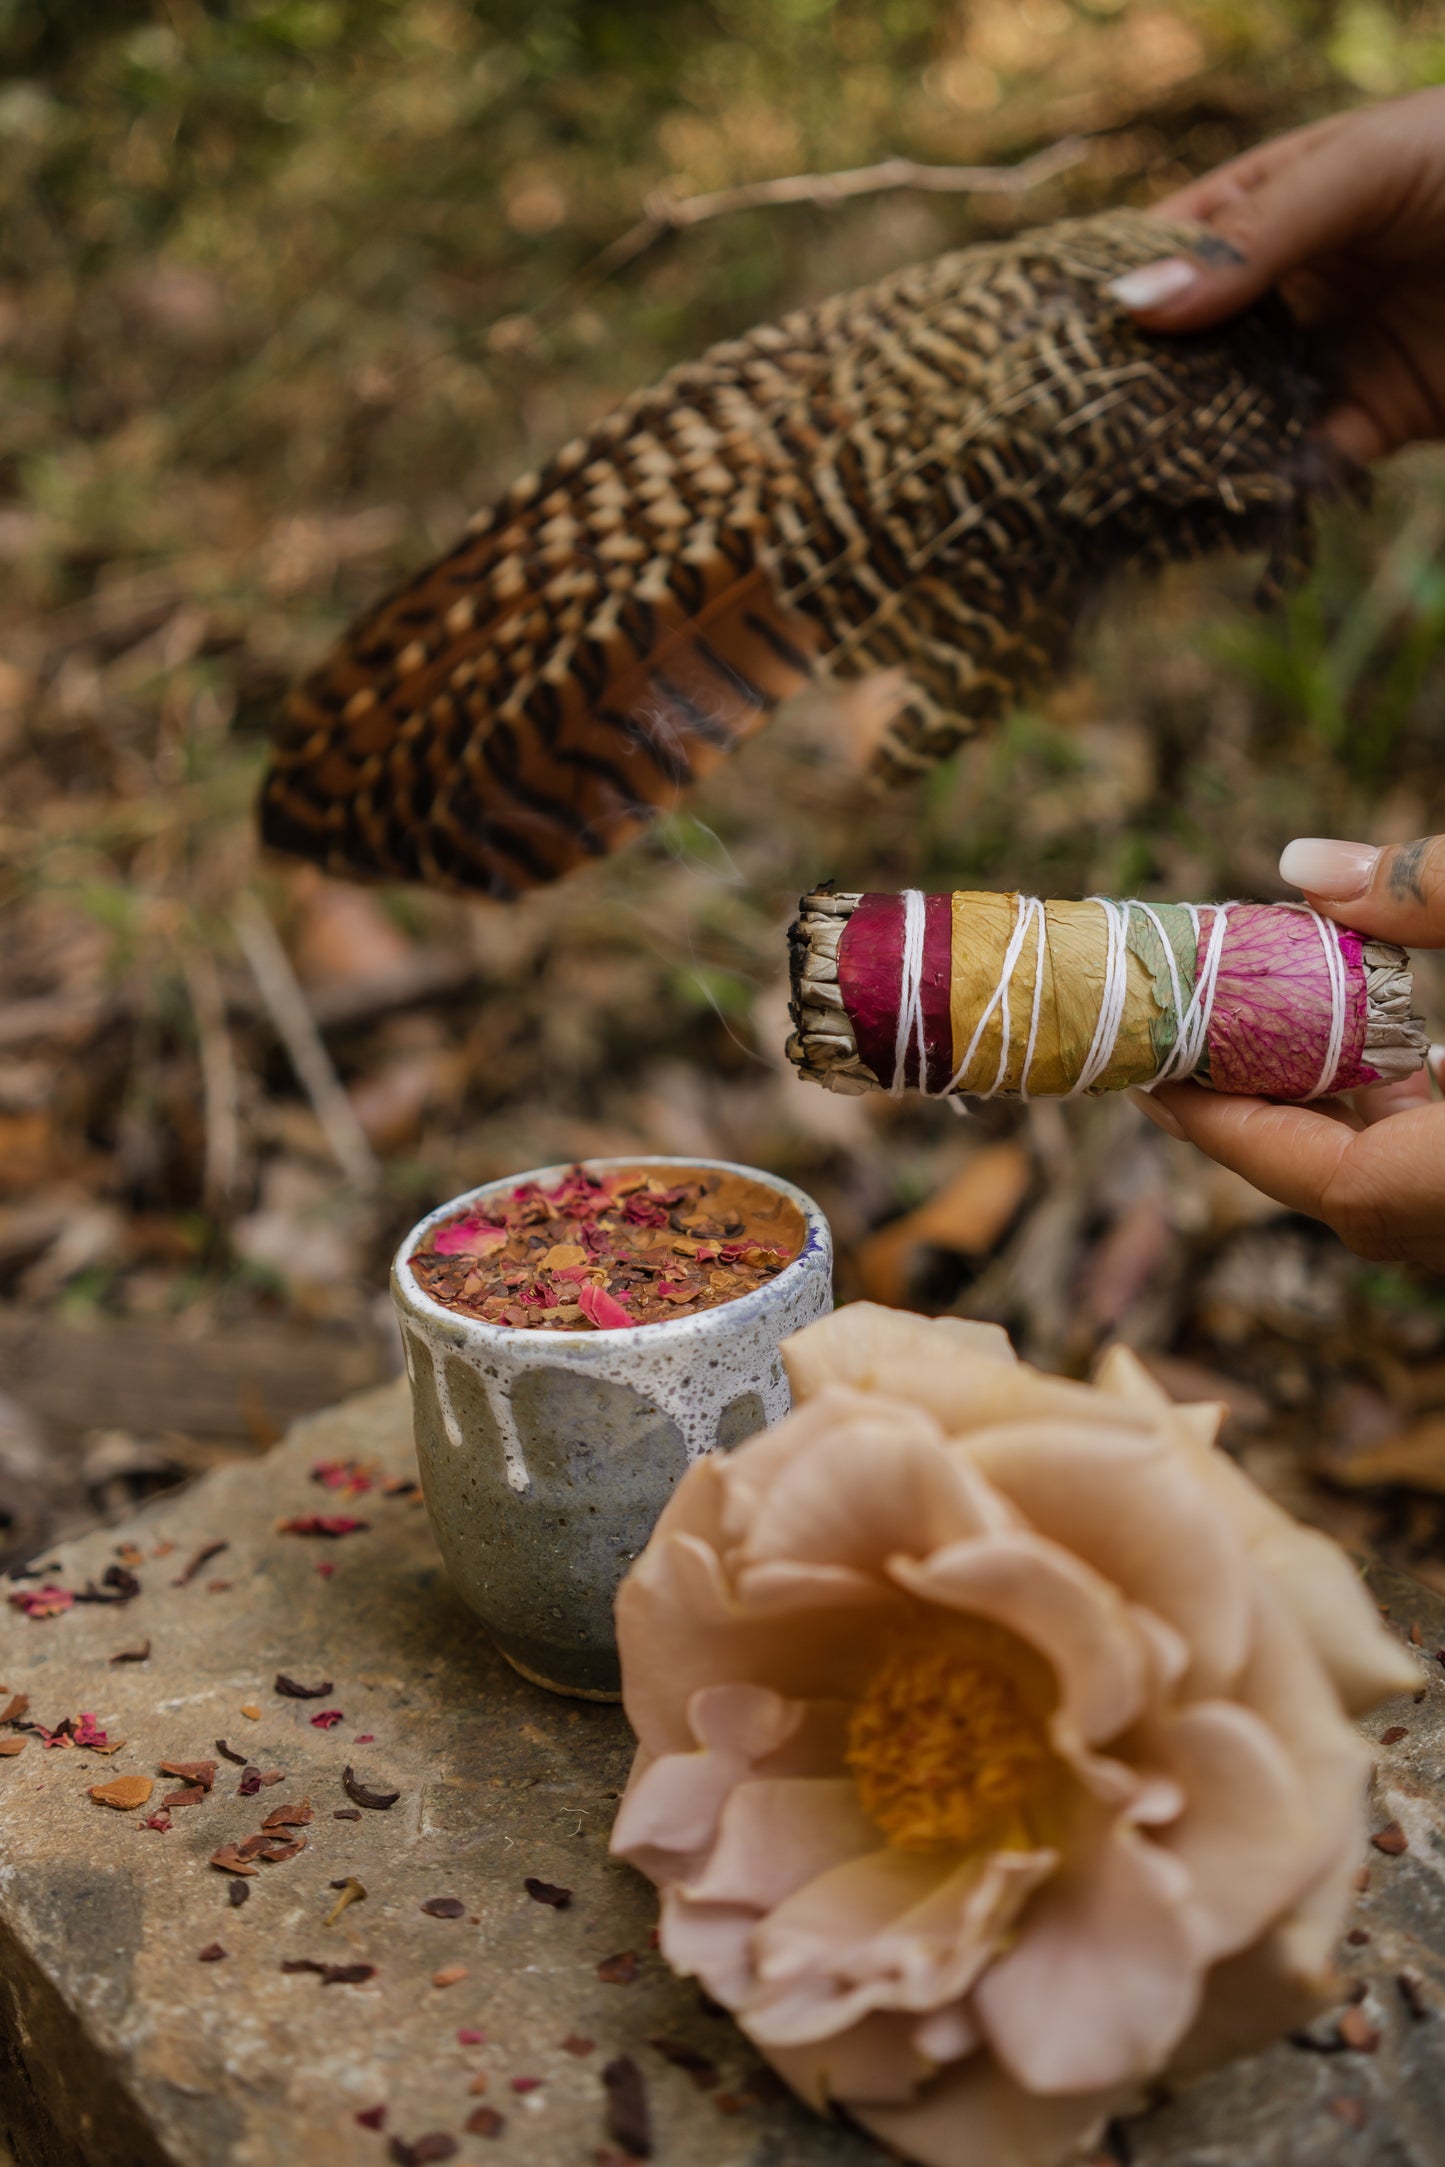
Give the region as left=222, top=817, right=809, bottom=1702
left=1111, top=89, right=1445, bottom=459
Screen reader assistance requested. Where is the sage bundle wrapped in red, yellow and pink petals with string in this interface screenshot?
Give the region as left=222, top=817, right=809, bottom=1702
left=789, top=888, right=1428, bottom=1099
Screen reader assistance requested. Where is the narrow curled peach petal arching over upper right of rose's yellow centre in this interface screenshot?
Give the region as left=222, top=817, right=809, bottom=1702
left=888, top=1530, right=1148, bottom=1744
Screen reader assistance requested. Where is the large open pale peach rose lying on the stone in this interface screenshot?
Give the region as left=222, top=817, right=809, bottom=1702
left=613, top=1302, right=1419, bottom=2167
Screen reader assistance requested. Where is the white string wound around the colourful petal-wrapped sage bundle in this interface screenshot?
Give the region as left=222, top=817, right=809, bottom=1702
left=890, top=888, right=1350, bottom=1099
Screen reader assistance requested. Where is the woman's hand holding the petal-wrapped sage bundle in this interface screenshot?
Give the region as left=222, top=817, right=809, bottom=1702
left=1133, top=834, right=1445, bottom=1272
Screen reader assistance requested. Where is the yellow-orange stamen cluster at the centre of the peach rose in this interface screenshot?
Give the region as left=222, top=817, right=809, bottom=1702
left=847, top=1610, right=1066, bottom=1851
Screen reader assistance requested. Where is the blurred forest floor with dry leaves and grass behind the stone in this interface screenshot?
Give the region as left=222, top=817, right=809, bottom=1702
left=0, top=0, right=1445, bottom=1584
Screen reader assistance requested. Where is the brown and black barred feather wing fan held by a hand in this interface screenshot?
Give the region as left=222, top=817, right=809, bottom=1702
left=262, top=210, right=1339, bottom=897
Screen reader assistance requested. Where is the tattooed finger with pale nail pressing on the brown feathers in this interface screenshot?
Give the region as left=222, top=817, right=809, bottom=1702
left=1109, top=113, right=1397, bottom=332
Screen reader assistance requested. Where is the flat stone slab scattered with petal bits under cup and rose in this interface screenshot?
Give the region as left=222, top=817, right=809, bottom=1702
left=0, top=1385, right=1445, bottom=2167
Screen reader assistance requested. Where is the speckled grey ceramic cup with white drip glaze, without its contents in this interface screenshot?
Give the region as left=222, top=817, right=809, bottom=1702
left=392, top=1157, right=832, bottom=1701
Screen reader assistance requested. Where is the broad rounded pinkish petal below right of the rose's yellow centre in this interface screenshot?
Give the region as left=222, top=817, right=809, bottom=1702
left=973, top=1825, right=1202, bottom=2093
